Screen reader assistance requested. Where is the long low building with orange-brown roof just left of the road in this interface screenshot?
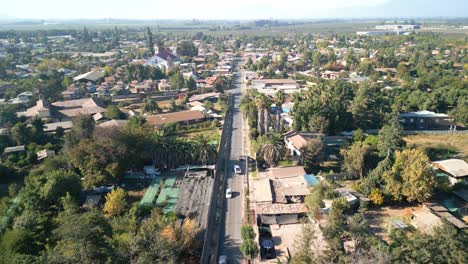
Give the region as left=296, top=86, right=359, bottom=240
left=146, top=111, right=205, bottom=126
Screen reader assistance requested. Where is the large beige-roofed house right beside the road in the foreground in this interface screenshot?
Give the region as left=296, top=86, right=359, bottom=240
left=252, top=166, right=310, bottom=225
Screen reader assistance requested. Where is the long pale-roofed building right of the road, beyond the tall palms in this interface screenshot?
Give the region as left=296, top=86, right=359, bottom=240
left=252, top=79, right=301, bottom=96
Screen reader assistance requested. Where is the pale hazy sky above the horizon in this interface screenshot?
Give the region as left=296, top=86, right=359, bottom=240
left=0, top=0, right=468, bottom=19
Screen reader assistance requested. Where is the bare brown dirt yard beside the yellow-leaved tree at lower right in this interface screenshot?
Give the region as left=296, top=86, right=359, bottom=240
left=366, top=206, right=417, bottom=240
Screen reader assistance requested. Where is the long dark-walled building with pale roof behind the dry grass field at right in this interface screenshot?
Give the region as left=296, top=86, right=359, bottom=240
left=400, top=111, right=455, bottom=130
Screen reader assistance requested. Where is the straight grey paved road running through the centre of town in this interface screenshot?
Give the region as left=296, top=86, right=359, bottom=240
left=219, top=63, right=246, bottom=263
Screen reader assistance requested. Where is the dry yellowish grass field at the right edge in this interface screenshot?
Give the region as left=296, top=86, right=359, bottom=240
left=405, top=134, right=468, bottom=160
